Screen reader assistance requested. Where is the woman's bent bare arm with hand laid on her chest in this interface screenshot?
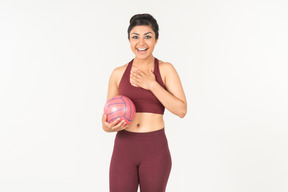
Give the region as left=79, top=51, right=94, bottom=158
left=131, top=63, right=187, bottom=118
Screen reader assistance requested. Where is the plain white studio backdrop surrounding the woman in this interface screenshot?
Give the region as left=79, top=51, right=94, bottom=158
left=0, top=0, right=288, bottom=192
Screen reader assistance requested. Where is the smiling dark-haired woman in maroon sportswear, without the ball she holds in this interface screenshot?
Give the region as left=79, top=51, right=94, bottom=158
left=102, top=14, right=187, bottom=192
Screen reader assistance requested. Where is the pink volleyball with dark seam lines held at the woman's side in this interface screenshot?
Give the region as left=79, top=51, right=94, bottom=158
left=104, top=95, right=136, bottom=125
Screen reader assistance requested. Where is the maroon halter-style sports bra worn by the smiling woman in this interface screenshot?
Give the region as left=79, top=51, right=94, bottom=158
left=119, top=58, right=166, bottom=114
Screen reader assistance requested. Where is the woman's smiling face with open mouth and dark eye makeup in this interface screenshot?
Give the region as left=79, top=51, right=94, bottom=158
left=129, top=25, right=157, bottom=59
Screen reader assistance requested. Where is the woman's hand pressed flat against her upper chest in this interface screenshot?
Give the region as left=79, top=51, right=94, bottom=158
left=130, top=69, right=156, bottom=90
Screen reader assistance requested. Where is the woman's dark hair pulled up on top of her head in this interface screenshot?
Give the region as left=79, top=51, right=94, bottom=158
left=128, top=13, right=159, bottom=39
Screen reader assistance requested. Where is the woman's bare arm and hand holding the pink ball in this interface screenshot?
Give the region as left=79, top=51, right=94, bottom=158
left=102, top=68, right=128, bottom=132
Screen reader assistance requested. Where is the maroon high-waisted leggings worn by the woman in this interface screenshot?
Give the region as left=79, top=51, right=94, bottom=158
left=109, top=128, right=172, bottom=192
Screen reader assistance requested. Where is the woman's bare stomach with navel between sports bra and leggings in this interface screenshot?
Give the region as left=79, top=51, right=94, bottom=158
left=126, top=113, right=164, bottom=132
